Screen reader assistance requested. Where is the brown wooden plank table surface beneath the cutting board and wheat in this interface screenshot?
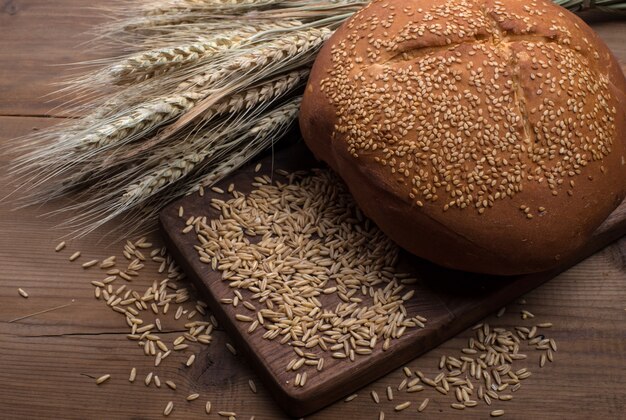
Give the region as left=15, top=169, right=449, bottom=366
left=0, top=0, right=626, bottom=419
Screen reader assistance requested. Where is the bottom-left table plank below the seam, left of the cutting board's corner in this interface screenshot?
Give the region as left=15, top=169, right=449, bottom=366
left=0, top=332, right=282, bottom=419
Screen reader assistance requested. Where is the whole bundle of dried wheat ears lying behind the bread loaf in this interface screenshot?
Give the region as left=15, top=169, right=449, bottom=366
left=13, top=0, right=626, bottom=234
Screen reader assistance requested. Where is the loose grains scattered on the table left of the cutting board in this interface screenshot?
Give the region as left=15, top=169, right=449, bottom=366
left=55, top=238, right=244, bottom=416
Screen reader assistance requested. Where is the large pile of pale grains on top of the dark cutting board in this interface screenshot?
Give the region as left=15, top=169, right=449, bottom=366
left=179, top=170, right=426, bottom=386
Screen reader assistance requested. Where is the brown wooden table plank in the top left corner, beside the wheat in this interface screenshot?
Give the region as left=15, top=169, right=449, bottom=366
left=0, top=0, right=111, bottom=116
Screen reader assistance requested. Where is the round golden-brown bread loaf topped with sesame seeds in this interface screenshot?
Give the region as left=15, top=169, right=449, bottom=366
left=300, top=0, right=626, bottom=275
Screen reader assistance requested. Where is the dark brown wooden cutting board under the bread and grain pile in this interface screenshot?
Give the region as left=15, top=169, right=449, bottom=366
left=160, top=144, right=626, bottom=417
